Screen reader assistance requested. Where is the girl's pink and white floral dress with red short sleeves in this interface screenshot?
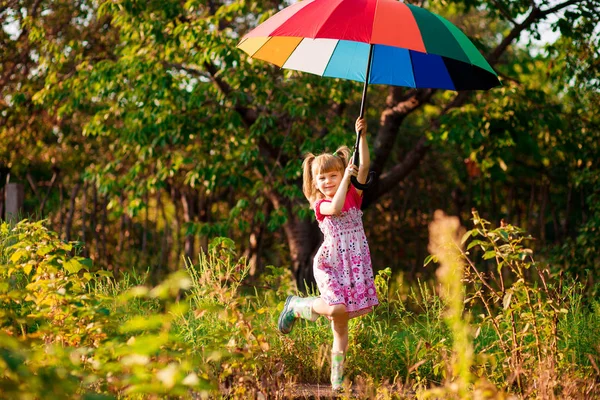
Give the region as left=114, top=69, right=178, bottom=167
left=313, top=186, right=379, bottom=318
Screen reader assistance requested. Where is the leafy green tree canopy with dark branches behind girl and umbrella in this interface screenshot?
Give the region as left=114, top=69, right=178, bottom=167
left=0, top=0, right=600, bottom=286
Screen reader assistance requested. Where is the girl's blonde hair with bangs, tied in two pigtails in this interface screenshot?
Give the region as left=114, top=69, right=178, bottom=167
left=302, top=146, right=350, bottom=208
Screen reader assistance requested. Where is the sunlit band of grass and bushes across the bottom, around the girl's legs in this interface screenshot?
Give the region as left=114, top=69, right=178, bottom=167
left=0, top=219, right=600, bottom=398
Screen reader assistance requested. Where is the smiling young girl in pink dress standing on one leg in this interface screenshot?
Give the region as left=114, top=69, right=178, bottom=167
left=278, top=118, right=379, bottom=391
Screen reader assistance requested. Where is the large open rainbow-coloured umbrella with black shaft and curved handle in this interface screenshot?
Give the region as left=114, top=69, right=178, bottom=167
left=238, top=0, right=500, bottom=189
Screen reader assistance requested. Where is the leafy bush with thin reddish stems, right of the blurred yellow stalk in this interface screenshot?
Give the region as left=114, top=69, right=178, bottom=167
left=462, top=211, right=600, bottom=397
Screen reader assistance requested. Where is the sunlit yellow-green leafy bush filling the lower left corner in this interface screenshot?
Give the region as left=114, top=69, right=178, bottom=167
left=0, top=221, right=211, bottom=398
